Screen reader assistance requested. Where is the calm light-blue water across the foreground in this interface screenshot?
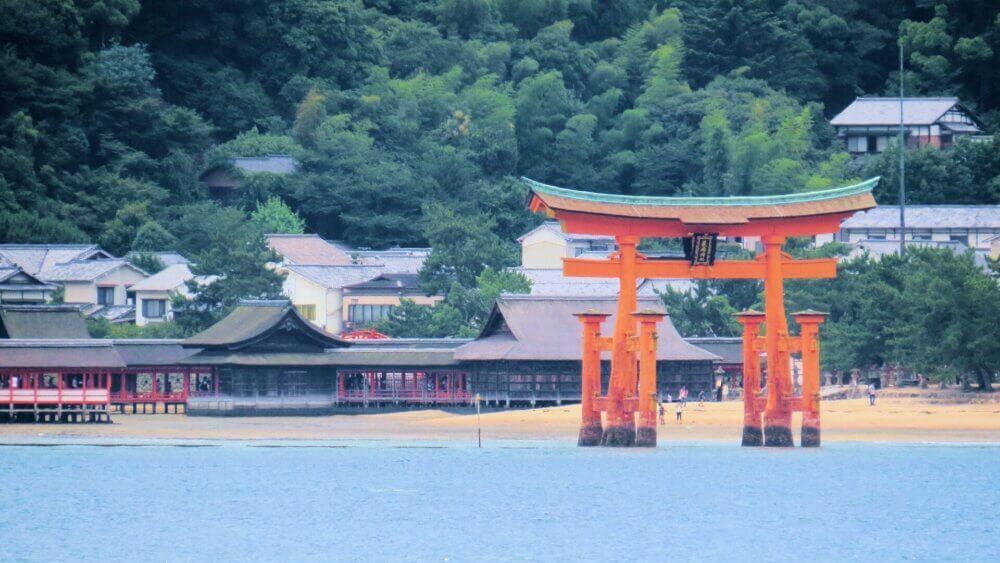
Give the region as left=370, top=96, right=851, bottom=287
left=0, top=443, right=1000, bottom=561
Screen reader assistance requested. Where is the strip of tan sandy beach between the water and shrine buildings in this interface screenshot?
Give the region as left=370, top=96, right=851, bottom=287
left=0, top=392, right=1000, bottom=443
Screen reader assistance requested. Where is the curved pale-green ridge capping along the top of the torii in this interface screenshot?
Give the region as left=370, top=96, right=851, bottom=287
left=521, top=176, right=879, bottom=207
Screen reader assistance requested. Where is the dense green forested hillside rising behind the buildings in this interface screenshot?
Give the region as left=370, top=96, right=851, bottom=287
left=0, top=0, right=1000, bottom=253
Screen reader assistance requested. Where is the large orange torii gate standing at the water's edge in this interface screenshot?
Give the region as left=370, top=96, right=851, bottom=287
left=523, top=178, right=879, bottom=446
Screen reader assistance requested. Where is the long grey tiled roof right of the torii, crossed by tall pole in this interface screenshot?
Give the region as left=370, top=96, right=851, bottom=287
left=841, top=205, right=1000, bottom=229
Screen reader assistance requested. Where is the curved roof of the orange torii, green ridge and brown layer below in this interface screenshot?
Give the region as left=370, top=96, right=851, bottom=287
left=522, top=177, right=879, bottom=225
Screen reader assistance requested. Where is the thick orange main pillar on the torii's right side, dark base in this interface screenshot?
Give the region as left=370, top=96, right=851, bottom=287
left=763, top=235, right=795, bottom=448
